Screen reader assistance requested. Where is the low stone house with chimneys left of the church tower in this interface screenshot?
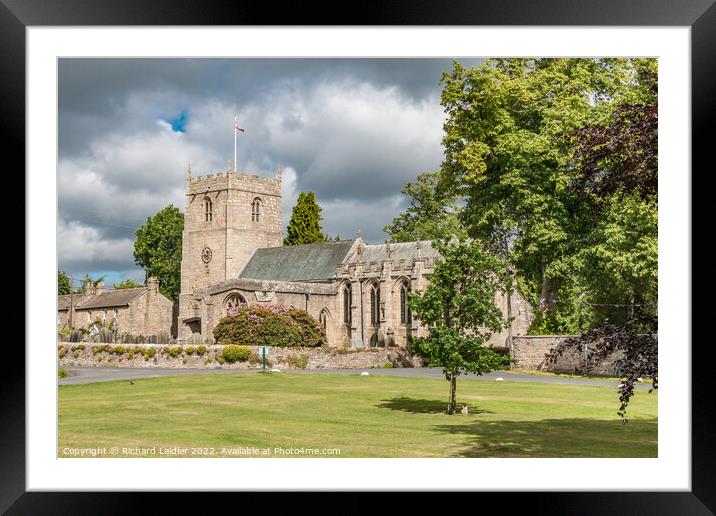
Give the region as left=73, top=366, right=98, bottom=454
left=57, top=278, right=175, bottom=336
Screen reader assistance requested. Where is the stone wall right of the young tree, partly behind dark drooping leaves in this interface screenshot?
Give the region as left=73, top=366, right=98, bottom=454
left=512, top=335, right=622, bottom=376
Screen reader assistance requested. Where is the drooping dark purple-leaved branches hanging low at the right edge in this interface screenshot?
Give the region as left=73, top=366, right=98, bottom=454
left=545, top=321, right=659, bottom=423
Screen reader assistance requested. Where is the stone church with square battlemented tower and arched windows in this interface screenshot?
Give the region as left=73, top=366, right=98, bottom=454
left=177, top=166, right=531, bottom=347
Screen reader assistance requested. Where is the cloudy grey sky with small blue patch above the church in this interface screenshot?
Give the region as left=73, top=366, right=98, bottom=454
left=57, top=59, right=479, bottom=284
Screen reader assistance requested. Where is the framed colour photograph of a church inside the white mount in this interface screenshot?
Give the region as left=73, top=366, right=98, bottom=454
left=56, top=55, right=661, bottom=462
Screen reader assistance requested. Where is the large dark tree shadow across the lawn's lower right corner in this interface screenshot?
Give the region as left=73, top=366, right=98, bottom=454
left=434, top=416, right=658, bottom=458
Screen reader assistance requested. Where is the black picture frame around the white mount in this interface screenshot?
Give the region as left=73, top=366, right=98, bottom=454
left=0, top=0, right=716, bottom=514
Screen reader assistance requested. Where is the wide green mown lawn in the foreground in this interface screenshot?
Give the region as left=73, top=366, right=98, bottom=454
left=58, top=373, right=657, bottom=457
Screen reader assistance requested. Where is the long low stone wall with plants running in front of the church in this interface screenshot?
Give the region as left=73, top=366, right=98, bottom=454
left=57, top=342, right=420, bottom=370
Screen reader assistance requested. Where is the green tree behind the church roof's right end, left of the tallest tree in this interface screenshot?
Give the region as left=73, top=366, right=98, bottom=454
left=383, top=172, right=466, bottom=242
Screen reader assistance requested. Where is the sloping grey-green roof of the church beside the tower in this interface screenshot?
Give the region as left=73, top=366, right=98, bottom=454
left=239, top=240, right=353, bottom=281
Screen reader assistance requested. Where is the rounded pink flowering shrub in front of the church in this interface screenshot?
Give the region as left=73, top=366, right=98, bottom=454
left=214, top=305, right=325, bottom=347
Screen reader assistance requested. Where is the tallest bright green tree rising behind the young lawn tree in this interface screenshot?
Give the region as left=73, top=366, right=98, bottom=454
left=440, top=58, right=656, bottom=331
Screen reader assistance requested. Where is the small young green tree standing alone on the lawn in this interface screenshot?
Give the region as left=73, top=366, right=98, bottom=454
left=409, top=239, right=512, bottom=414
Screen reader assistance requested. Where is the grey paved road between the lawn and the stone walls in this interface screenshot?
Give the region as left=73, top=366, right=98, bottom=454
left=59, top=367, right=650, bottom=388
